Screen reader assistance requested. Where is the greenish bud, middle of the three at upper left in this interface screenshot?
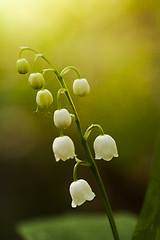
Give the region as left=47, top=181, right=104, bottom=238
left=28, top=73, right=45, bottom=89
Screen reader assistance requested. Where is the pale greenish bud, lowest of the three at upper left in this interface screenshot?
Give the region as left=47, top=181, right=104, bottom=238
left=36, top=89, right=53, bottom=108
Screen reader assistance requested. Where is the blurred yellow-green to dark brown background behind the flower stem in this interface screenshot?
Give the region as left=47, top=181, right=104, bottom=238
left=0, top=0, right=160, bottom=240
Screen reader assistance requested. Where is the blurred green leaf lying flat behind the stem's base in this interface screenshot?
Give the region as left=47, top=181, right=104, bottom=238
left=18, top=214, right=136, bottom=240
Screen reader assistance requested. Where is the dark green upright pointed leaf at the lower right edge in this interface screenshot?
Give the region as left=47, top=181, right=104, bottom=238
left=132, top=137, right=160, bottom=240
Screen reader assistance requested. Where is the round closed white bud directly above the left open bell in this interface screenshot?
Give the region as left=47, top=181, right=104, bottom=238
left=54, top=109, right=72, bottom=129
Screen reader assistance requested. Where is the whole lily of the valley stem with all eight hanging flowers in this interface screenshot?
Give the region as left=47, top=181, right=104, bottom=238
left=17, top=47, right=119, bottom=240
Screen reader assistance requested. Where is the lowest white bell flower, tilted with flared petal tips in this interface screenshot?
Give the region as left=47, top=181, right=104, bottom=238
left=69, top=179, right=95, bottom=208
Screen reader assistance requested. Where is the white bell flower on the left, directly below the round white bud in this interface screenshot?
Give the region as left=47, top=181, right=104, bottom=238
left=52, top=136, right=76, bottom=162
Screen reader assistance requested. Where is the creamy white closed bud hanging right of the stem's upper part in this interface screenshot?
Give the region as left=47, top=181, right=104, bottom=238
left=73, top=78, right=90, bottom=97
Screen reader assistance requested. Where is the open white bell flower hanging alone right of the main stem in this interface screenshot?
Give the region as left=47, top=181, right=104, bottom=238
left=93, top=134, right=118, bottom=161
